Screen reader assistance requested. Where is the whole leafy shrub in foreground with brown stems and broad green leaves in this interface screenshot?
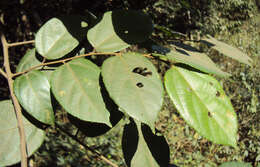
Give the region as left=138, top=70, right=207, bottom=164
left=0, top=10, right=251, bottom=166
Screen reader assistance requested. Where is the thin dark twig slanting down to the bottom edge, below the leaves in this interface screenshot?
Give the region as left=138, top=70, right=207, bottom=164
left=55, top=123, right=118, bottom=167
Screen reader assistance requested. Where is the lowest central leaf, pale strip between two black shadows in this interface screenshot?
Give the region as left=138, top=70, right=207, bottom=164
left=122, top=120, right=173, bottom=167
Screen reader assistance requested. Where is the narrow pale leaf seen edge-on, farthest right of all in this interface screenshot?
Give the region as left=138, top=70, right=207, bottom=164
left=201, top=35, right=252, bottom=65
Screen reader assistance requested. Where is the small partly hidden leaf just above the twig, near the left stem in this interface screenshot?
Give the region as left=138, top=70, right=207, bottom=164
left=16, top=48, right=41, bottom=72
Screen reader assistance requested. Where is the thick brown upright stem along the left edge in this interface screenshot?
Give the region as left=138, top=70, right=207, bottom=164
left=1, top=34, right=27, bottom=167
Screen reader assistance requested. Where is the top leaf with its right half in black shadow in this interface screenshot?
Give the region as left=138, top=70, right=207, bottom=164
left=87, top=10, right=153, bottom=52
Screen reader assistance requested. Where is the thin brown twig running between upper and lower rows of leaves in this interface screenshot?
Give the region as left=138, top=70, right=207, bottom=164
left=13, top=52, right=120, bottom=77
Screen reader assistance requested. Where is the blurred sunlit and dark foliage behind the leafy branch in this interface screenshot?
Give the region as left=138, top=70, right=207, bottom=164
left=0, top=0, right=260, bottom=167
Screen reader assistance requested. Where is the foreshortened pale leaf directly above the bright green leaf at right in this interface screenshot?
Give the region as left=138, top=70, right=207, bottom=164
left=166, top=43, right=230, bottom=77
